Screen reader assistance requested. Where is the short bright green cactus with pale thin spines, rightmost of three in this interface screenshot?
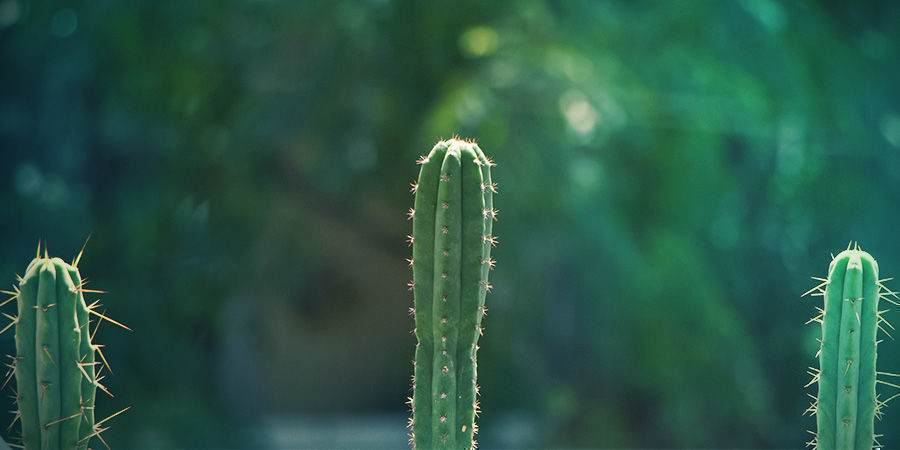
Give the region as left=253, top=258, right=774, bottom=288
left=803, top=243, right=900, bottom=450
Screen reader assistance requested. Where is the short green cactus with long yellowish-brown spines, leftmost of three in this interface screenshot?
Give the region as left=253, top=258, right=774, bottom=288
left=0, top=243, right=128, bottom=450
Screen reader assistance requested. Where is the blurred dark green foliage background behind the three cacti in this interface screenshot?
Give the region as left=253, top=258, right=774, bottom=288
left=0, top=0, right=900, bottom=449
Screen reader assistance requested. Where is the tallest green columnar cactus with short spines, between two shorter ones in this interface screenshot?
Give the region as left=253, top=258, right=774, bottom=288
left=408, top=139, right=497, bottom=449
